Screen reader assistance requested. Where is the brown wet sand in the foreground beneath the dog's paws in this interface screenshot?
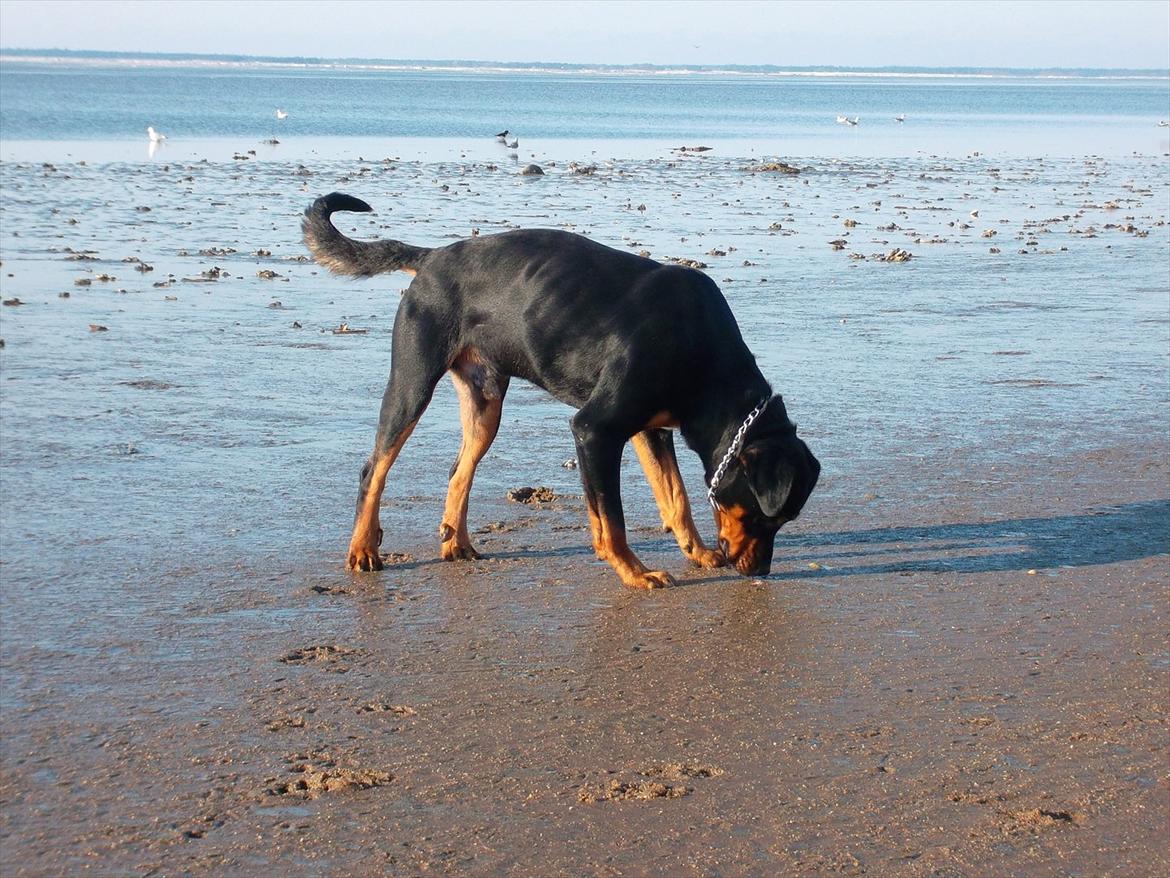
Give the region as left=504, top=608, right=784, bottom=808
left=4, top=447, right=1170, bottom=876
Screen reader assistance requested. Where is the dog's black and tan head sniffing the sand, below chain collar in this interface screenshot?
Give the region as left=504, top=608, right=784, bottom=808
left=715, top=407, right=820, bottom=576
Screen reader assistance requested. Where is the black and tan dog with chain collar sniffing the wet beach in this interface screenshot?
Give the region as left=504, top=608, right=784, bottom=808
left=303, top=192, right=820, bottom=588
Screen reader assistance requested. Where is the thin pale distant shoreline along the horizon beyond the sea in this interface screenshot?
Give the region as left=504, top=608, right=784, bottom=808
left=0, top=48, right=1170, bottom=81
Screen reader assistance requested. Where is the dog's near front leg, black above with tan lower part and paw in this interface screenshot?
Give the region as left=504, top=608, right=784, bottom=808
left=573, top=410, right=675, bottom=589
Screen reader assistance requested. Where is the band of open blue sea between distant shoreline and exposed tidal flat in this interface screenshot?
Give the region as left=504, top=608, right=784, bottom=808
left=0, top=50, right=1170, bottom=158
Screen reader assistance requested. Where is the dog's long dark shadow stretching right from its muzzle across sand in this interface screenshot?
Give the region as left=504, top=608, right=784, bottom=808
left=773, top=500, right=1170, bottom=579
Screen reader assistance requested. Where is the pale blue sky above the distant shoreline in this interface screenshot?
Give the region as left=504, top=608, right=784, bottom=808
left=0, top=0, right=1170, bottom=69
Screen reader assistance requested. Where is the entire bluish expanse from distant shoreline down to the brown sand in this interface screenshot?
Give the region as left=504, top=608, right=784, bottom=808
left=0, top=50, right=1170, bottom=604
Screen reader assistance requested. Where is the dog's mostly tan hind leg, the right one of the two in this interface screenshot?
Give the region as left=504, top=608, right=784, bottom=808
left=439, top=363, right=508, bottom=561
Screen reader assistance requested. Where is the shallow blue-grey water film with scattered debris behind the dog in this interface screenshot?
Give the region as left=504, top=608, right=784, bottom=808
left=0, top=142, right=1170, bottom=625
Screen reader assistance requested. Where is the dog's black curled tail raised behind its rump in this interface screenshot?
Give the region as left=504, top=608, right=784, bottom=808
left=301, top=192, right=431, bottom=277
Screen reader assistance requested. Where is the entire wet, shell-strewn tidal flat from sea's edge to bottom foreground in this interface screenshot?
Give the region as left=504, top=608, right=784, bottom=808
left=0, top=144, right=1170, bottom=878
